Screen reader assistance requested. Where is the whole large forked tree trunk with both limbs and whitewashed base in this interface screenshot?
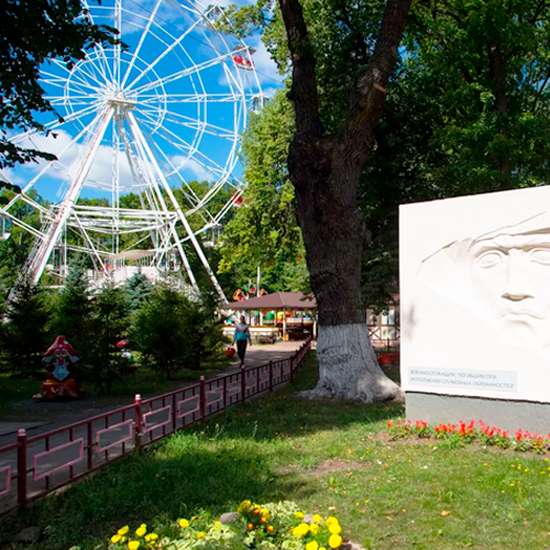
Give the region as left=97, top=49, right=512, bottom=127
left=279, top=0, right=410, bottom=402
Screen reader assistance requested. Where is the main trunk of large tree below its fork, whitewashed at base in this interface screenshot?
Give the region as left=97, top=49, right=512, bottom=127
left=289, top=152, right=401, bottom=403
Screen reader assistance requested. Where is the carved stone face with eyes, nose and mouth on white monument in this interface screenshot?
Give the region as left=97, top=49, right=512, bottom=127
left=470, top=233, right=550, bottom=347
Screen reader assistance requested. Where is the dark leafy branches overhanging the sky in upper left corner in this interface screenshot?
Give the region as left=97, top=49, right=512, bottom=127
left=0, top=0, right=117, bottom=172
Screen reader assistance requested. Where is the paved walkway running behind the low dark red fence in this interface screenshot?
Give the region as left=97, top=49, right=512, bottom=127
left=0, top=341, right=303, bottom=446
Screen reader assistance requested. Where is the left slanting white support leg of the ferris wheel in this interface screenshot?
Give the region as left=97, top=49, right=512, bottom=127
left=28, top=109, right=113, bottom=284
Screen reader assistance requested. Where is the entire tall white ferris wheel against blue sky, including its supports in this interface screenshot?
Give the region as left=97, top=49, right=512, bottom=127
left=2, top=0, right=263, bottom=302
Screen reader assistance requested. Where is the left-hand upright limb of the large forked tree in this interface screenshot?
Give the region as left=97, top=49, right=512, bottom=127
left=279, top=0, right=323, bottom=141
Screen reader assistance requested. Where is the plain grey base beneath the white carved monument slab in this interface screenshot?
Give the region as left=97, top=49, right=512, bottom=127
left=405, top=392, right=550, bottom=434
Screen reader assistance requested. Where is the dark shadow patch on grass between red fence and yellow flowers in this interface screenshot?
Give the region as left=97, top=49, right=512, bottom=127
left=5, top=446, right=309, bottom=550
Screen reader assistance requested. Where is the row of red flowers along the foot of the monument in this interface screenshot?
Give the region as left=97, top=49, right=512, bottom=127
left=387, top=420, right=550, bottom=454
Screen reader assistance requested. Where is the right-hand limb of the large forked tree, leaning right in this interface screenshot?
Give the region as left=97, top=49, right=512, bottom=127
left=342, top=0, right=411, bottom=169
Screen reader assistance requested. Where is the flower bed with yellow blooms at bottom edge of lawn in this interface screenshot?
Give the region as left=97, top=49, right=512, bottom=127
left=108, top=500, right=356, bottom=550
